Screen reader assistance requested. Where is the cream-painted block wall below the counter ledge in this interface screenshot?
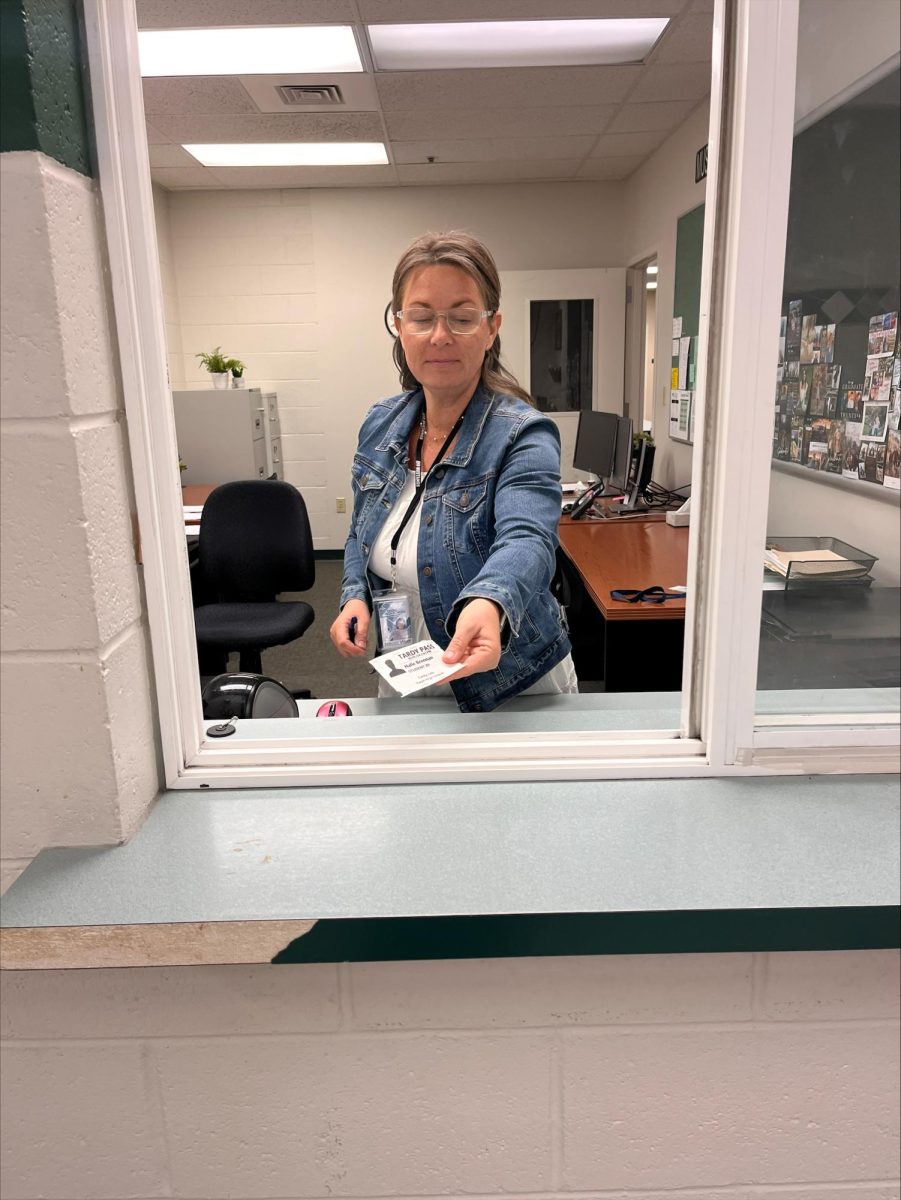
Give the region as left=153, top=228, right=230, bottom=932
left=2, top=952, right=899, bottom=1200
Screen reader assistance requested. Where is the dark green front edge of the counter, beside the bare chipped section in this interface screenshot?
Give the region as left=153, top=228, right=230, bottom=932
left=272, top=905, right=901, bottom=964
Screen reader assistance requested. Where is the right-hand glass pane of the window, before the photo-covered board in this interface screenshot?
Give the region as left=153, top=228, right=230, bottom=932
left=758, top=18, right=901, bottom=720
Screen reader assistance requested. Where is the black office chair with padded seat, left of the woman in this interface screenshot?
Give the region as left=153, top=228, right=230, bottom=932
left=194, top=479, right=316, bottom=676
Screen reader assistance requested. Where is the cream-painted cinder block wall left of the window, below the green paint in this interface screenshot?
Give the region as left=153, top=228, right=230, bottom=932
left=0, top=151, right=158, bottom=882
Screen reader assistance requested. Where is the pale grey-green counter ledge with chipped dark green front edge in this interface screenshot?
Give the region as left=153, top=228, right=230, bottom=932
left=2, top=775, right=899, bottom=970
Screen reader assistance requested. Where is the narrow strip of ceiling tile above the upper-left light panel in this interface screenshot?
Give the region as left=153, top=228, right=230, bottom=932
left=136, top=0, right=355, bottom=29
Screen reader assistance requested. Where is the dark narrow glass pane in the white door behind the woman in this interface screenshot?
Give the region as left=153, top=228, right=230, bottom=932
left=529, top=300, right=594, bottom=413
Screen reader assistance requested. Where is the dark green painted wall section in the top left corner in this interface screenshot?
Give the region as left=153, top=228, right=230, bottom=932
left=0, top=0, right=94, bottom=175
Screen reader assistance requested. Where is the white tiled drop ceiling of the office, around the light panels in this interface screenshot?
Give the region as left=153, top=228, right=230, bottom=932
left=137, top=0, right=713, bottom=191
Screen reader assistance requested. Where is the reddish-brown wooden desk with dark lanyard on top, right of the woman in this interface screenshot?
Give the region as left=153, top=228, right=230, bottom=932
left=559, top=517, right=689, bottom=691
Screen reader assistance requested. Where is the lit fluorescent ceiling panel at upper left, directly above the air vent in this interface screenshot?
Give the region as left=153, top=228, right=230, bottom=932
left=138, top=25, right=364, bottom=77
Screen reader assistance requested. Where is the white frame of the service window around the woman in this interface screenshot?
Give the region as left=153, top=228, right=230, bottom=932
left=84, top=0, right=899, bottom=788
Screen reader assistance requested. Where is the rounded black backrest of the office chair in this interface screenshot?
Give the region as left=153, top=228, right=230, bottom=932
left=199, top=479, right=316, bottom=600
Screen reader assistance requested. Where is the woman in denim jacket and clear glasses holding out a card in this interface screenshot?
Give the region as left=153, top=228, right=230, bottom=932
left=331, top=233, right=577, bottom=712
